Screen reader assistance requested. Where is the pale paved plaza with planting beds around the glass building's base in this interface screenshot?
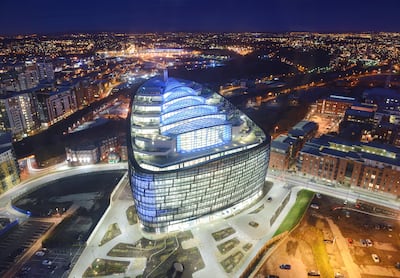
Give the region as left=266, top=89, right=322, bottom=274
left=70, top=176, right=298, bottom=277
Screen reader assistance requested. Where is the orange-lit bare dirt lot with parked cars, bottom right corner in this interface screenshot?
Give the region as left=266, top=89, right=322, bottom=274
left=256, top=196, right=400, bottom=278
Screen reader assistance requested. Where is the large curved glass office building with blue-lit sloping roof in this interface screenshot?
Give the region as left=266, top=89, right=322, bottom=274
left=128, top=74, right=270, bottom=233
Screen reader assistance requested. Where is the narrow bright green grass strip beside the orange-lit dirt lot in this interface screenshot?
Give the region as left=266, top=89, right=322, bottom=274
left=274, top=190, right=314, bottom=236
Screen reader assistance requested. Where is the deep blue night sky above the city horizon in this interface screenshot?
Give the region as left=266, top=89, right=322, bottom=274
left=0, top=0, right=400, bottom=35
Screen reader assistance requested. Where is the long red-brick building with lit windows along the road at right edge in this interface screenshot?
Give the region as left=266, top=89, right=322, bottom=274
left=298, top=135, right=400, bottom=197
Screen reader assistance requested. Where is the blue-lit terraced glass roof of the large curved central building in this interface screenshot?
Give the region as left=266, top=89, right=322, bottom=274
left=130, top=77, right=269, bottom=170
